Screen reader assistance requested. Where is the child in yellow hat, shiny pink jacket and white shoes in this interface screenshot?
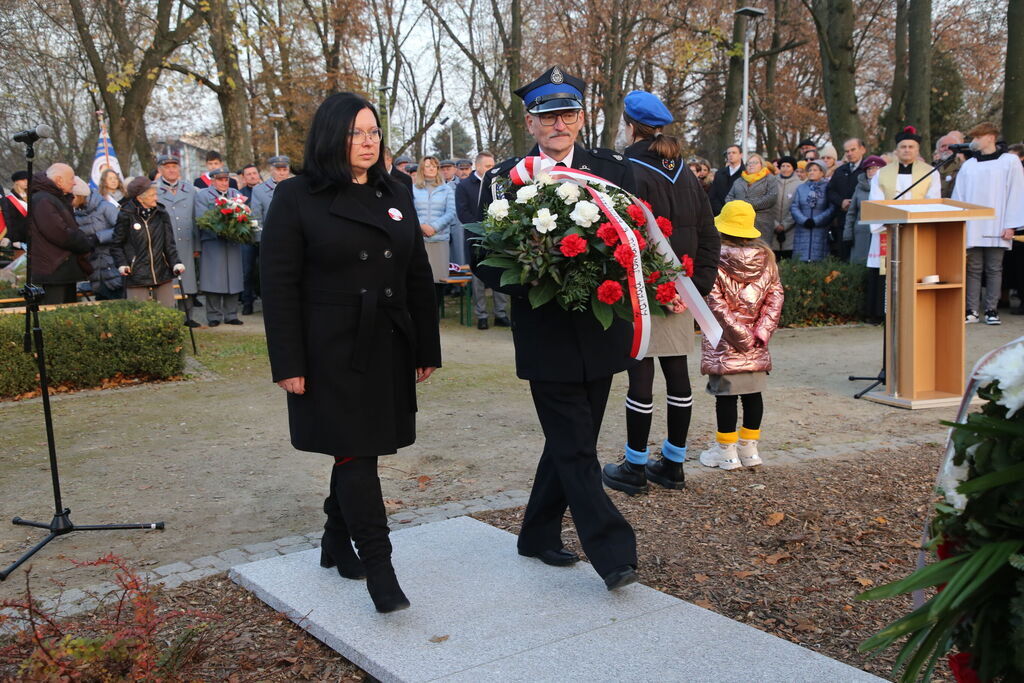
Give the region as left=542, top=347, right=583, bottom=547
left=700, top=201, right=784, bottom=470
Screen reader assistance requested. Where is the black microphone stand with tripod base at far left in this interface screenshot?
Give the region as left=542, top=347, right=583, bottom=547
left=0, top=135, right=164, bottom=581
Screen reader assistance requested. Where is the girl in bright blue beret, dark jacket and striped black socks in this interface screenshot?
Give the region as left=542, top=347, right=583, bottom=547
left=601, top=90, right=721, bottom=494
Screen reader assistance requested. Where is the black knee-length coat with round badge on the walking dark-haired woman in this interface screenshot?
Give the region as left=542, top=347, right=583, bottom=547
left=260, top=171, right=441, bottom=457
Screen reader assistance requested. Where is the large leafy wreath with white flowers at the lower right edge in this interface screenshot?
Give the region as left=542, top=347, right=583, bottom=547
left=859, top=338, right=1024, bottom=681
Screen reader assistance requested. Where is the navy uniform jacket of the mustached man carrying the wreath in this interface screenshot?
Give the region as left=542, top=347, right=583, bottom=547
left=471, top=144, right=636, bottom=382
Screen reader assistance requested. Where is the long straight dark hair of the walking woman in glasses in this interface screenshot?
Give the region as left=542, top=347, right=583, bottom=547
left=302, top=92, right=387, bottom=185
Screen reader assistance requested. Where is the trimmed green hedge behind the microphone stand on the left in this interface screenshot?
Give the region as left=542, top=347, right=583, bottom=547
left=0, top=301, right=185, bottom=397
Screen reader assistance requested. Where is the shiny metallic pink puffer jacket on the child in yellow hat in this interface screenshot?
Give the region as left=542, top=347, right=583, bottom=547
left=700, top=243, right=783, bottom=375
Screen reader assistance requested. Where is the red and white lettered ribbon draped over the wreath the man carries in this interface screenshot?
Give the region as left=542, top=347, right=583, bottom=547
left=509, top=157, right=722, bottom=359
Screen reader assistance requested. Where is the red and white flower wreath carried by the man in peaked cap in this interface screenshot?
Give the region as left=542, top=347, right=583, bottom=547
left=469, top=162, right=693, bottom=329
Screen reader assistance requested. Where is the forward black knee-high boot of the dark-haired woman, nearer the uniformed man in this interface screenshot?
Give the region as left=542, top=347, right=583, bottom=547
left=334, top=458, right=409, bottom=612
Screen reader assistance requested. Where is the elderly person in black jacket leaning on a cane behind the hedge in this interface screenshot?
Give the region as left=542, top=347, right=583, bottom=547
left=111, top=175, right=185, bottom=308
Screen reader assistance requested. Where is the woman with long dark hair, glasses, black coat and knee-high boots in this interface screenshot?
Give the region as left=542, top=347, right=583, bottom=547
left=260, top=92, right=440, bottom=612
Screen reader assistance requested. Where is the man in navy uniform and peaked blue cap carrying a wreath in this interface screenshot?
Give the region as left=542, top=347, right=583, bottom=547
left=471, top=67, right=637, bottom=591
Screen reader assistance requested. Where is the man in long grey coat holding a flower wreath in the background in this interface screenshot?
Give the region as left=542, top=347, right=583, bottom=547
left=195, top=168, right=243, bottom=328
